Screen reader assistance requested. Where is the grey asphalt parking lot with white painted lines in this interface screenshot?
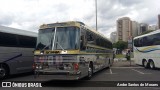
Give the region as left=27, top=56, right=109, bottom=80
left=0, top=61, right=160, bottom=90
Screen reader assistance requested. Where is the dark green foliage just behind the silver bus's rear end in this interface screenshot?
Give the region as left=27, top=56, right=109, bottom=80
left=113, top=41, right=128, bottom=50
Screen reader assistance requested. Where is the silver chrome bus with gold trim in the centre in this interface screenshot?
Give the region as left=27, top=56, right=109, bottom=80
left=33, top=21, right=113, bottom=80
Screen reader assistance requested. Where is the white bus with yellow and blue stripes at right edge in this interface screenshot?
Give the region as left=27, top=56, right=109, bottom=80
left=134, top=30, right=160, bottom=69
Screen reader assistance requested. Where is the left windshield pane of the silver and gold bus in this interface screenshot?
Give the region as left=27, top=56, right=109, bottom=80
left=36, top=28, right=55, bottom=50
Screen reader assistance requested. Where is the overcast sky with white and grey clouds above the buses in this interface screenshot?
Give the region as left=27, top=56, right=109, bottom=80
left=0, top=0, right=160, bottom=38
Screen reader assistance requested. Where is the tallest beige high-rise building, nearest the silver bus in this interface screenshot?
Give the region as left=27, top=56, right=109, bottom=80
left=117, top=17, right=132, bottom=42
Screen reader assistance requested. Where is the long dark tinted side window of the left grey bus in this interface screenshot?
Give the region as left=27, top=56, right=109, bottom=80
left=0, top=32, right=36, bottom=48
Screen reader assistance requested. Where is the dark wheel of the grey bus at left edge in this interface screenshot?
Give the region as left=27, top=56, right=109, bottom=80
left=0, top=64, right=9, bottom=79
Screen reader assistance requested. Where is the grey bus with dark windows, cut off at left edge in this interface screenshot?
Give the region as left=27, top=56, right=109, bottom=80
left=0, top=26, right=38, bottom=79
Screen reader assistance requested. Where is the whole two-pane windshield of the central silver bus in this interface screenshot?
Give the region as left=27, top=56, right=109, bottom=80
left=36, top=26, right=80, bottom=50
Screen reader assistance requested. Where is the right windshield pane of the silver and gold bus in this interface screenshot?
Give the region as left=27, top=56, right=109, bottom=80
left=54, top=27, right=80, bottom=50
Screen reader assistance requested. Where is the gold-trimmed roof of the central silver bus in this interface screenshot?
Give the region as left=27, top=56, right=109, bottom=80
left=40, top=21, right=111, bottom=42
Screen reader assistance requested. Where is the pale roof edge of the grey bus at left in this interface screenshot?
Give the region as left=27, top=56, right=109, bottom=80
left=0, top=26, right=38, bottom=37
